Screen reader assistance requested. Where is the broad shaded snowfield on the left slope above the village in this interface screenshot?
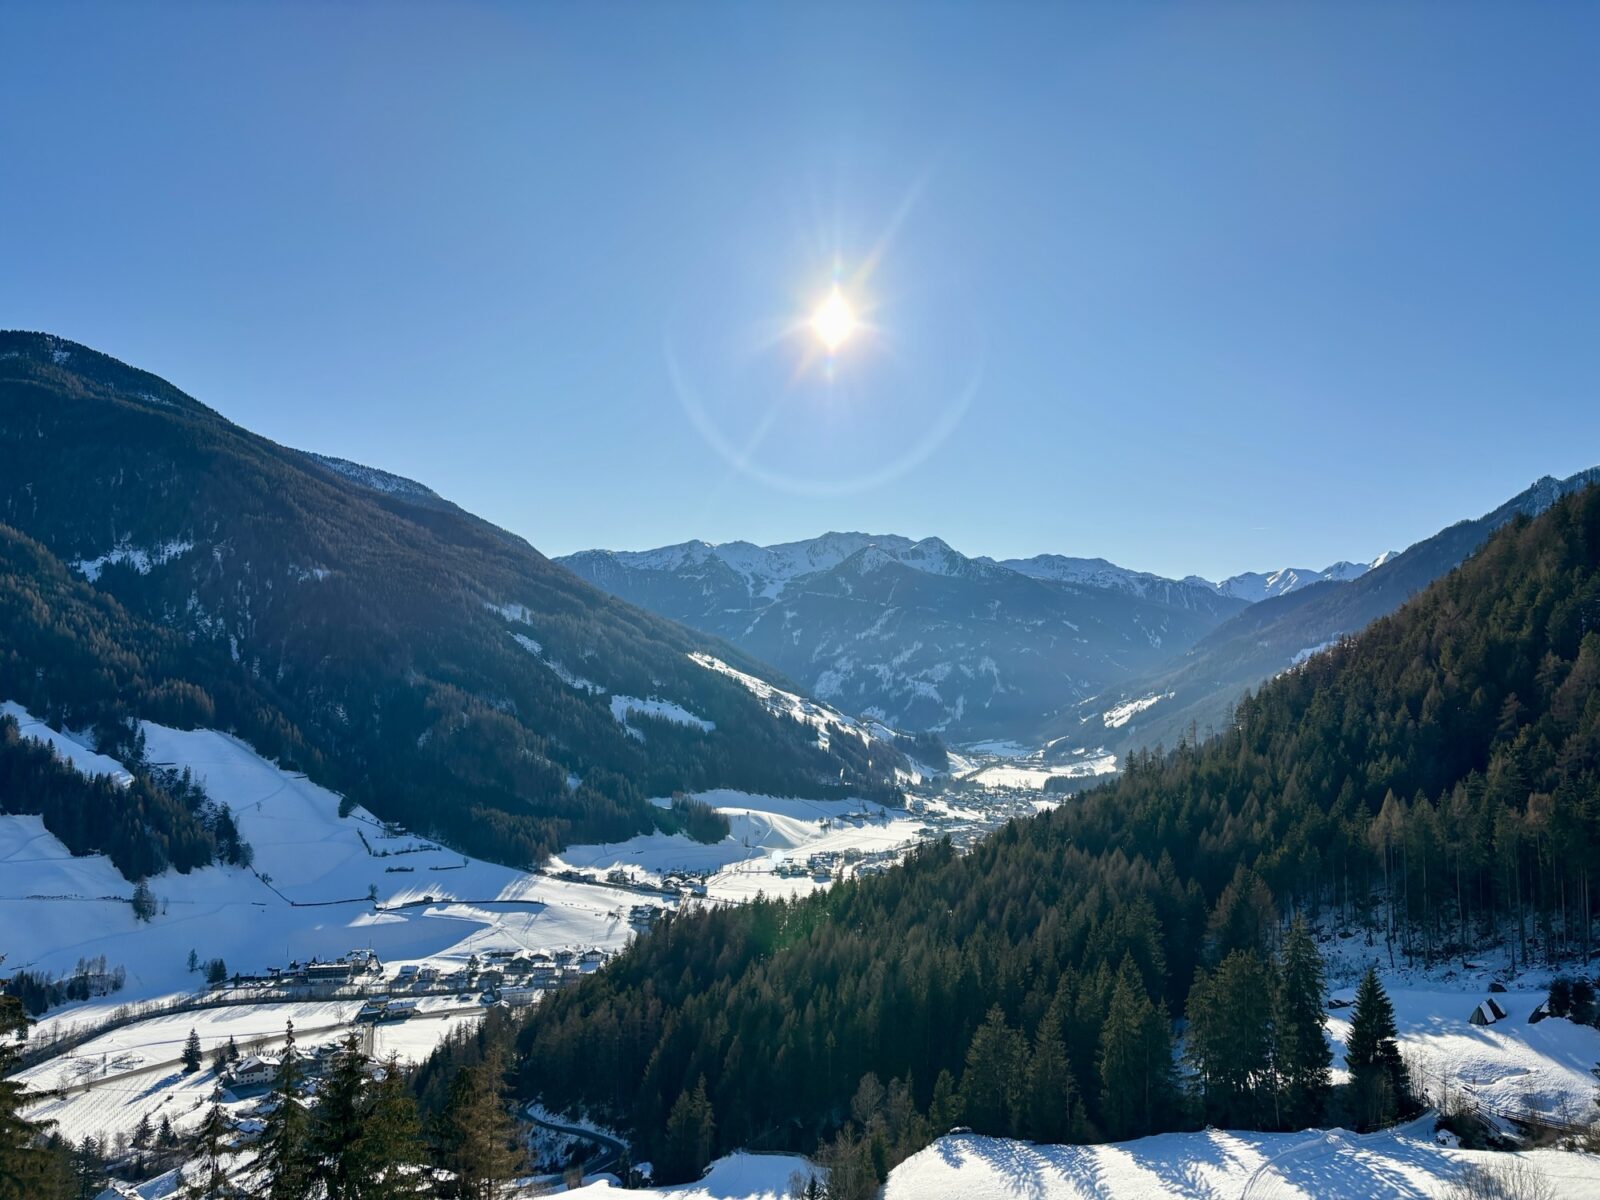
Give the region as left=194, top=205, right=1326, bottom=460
left=0, top=710, right=643, bottom=1032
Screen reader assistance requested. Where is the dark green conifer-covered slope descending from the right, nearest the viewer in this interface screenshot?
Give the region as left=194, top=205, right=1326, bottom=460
left=522, top=488, right=1600, bottom=1177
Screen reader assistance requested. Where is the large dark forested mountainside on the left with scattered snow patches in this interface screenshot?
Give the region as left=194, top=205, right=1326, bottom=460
left=0, top=333, right=906, bottom=864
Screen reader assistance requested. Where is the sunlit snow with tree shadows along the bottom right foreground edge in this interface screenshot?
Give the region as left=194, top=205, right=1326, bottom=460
left=883, top=1120, right=1600, bottom=1200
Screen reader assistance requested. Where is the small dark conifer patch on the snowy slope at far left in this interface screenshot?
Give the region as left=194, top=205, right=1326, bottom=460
left=0, top=715, right=250, bottom=880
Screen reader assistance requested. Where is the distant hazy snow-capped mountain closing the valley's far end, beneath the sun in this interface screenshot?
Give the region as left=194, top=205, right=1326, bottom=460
left=558, top=533, right=1245, bottom=739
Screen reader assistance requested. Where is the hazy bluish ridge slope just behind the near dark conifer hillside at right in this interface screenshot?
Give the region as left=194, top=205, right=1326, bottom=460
left=1035, top=467, right=1600, bottom=755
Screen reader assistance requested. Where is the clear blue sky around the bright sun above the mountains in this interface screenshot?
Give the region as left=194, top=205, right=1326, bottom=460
left=0, top=3, right=1600, bottom=576
